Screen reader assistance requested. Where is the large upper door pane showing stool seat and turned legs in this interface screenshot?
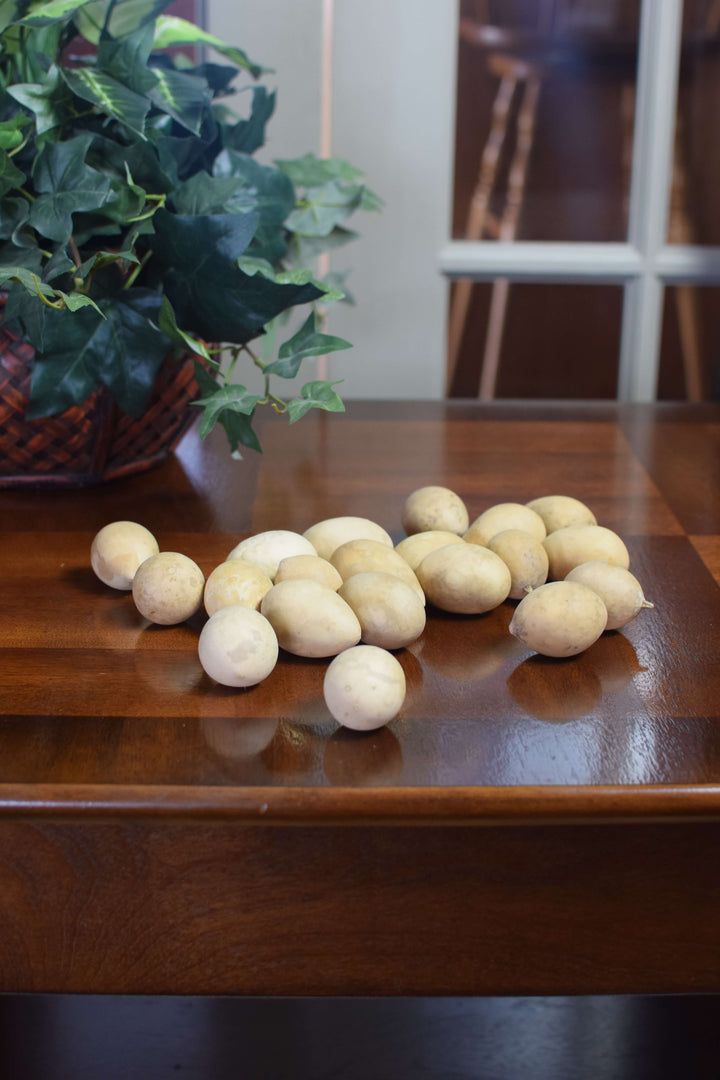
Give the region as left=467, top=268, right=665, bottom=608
left=452, top=0, right=639, bottom=241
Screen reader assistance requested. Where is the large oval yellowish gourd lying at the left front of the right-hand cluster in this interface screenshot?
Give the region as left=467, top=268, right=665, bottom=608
left=418, top=543, right=512, bottom=615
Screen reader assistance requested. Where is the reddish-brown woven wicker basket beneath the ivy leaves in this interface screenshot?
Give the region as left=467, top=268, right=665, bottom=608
left=0, top=308, right=198, bottom=488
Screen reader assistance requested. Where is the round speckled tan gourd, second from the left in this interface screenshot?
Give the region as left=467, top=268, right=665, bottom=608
left=133, top=551, right=205, bottom=626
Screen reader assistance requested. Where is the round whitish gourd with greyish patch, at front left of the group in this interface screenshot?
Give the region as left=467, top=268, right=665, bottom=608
left=198, top=604, right=279, bottom=686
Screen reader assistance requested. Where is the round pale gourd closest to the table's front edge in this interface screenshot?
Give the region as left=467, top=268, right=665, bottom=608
left=323, top=645, right=406, bottom=731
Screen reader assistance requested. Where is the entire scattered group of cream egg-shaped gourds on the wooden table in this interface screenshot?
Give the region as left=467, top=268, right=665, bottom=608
left=91, top=486, right=652, bottom=730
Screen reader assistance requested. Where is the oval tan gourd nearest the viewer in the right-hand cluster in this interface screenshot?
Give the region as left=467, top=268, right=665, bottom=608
left=510, top=581, right=608, bottom=657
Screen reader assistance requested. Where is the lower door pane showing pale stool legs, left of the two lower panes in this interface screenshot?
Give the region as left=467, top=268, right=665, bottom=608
left=448, top=279, right=623, bottom=399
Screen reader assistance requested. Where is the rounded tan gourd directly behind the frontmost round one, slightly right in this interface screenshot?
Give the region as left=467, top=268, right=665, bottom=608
left=338, top=570, right=425, bottom=649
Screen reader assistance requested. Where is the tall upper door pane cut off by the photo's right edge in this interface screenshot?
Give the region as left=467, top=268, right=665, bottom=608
left=667, top=0, right=720, bottom=244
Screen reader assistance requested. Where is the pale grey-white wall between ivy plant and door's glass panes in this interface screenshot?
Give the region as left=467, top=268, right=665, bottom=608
left=207, top=0, right=457, bottom=399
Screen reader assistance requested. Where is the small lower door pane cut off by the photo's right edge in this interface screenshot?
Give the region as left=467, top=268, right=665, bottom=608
left=657, top=285, right=720, bottom=401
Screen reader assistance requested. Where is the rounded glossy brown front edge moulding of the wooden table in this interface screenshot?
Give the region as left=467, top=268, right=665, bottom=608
left=0, top=783, right=720, bottom=827
